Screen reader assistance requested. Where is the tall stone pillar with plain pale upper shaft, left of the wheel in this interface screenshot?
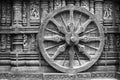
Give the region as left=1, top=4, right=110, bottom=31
left=11, top=0, right=25, bottom=70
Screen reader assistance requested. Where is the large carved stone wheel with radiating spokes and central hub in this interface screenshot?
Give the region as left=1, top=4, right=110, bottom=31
left=37, top=6, right=104, bottom=73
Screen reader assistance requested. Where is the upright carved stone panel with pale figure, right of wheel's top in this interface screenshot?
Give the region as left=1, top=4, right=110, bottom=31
left=103, top=1, right=113, bottom=25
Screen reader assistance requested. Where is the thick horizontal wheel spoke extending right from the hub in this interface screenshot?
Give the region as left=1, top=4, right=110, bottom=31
left=79, top=36, right=101, bottom=42
